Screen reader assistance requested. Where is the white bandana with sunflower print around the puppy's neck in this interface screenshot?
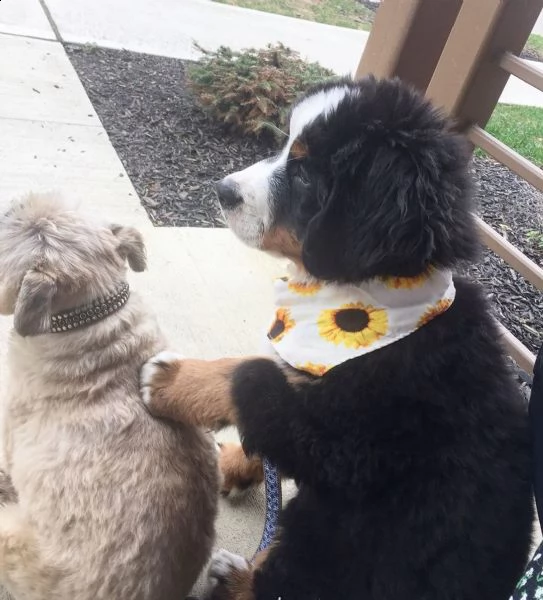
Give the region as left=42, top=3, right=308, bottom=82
left=268, top=267, right=456, bottom=376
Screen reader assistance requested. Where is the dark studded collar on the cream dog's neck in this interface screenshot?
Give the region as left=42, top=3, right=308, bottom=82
left=49, top=283, right=130, bottom=333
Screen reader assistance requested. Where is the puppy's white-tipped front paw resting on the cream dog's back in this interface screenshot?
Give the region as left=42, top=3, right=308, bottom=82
left=140, top=350, right=183, bottom=416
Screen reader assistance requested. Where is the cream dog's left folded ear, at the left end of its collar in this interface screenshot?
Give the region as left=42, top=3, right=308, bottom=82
left=14, top=269, right=57, bottom=337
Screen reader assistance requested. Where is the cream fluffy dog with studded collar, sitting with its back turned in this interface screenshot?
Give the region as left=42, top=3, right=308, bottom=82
left=0, top=195, right=218, bottom=600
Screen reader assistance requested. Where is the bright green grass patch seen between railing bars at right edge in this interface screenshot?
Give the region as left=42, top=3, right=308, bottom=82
left=480, top=104, right=543, bottom=167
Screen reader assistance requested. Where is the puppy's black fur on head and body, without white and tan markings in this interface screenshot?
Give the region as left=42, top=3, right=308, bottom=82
left=233, top=78, right=533, bottom=600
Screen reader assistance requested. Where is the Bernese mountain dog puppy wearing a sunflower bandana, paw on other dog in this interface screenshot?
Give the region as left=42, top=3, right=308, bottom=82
left=142, top=77, right=534, bottom=600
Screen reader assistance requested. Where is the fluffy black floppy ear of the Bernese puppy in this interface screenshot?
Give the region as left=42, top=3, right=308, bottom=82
left=303, top=125, right=478, bottom=281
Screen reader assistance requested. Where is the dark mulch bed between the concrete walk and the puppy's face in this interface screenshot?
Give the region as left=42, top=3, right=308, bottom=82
left=66, top=45, right=270, bottom=227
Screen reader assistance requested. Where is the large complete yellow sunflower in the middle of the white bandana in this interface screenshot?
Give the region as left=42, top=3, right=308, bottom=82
left=317, top=302, right=388, bottom=349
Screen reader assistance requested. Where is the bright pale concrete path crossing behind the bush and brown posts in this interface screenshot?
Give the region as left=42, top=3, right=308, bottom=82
left=40, top=0, right=543, bottom=106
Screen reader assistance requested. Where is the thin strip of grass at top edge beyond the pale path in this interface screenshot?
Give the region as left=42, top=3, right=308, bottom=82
left=212, top=0, right=373, bottom=30
